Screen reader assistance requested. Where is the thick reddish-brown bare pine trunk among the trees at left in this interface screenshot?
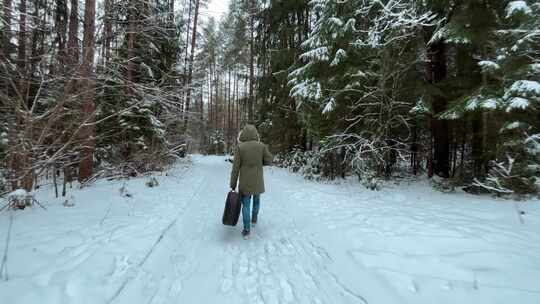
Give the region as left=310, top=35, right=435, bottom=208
left=79, top=0, right=96, bottom=181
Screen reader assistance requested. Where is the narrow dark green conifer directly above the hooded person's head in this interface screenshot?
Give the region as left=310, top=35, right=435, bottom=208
left=256, top=0, right=309, bottom=149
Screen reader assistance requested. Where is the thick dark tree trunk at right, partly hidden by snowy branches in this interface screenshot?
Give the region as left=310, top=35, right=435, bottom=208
left=426, top=42, right=451, bottom=178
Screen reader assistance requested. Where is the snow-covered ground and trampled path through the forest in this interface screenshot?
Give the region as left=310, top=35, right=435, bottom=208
left=0, top=156, right=540, bottom=304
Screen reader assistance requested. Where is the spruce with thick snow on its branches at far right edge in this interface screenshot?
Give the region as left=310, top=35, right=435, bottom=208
left=470, top=1, right=540, bottom=194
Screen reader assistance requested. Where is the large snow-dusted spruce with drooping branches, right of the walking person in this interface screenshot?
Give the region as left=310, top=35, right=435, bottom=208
left=289, top=1, right=434, bottom=176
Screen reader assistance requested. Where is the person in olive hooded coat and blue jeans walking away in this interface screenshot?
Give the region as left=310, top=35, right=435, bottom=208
left=230, top=124, right=273, bottom=239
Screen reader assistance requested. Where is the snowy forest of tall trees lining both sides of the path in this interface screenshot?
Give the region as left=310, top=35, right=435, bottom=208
left=0, top=0, right=540, bottom=202
